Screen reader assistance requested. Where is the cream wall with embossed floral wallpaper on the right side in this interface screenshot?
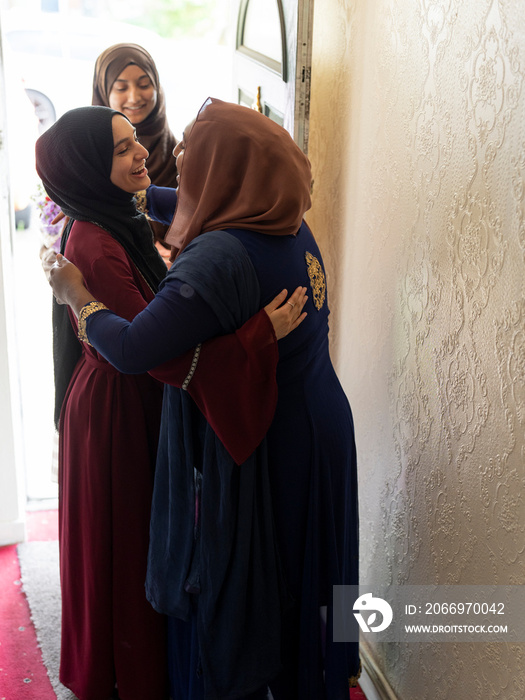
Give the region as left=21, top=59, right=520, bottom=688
left=308, top=0, right=525, bottom=700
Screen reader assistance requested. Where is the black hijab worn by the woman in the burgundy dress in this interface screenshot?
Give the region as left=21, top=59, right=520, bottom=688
left=36, top=107, right=166, bottom=428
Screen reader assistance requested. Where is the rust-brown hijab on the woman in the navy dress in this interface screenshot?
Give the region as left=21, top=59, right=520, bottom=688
left=166, top=98, right=311, bottom=251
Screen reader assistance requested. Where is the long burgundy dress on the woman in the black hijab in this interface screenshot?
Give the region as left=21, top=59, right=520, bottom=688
left=59, top=221, right=167, bottom=700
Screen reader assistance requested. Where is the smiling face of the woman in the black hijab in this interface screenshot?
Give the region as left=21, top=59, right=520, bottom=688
left=109, top=114, right=151, bottom=194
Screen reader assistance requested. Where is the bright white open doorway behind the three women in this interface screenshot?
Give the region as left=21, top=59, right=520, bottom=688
left=0, top=0, right=231, bottom=502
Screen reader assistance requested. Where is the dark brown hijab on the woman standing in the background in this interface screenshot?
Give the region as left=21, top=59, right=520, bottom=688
left=91, top=44, right=177, bottom=187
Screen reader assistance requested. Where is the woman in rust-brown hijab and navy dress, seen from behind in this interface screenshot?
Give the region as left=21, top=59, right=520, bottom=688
left=47, top=99, right=359, bottom=700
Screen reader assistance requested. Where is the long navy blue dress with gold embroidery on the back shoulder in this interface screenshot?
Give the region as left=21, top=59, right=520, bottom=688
left=87, top=219, right=359, bottom=700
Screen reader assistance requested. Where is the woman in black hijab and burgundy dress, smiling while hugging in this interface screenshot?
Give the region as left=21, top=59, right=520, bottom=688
left=36, top=106, right=302, bottom=700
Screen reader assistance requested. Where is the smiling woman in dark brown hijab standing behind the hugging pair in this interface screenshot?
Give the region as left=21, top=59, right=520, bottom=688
left=91, top=44, right=177, bottom=253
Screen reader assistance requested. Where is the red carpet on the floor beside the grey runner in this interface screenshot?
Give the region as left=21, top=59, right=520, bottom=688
left=0, top=510, right=366, bottom=700
